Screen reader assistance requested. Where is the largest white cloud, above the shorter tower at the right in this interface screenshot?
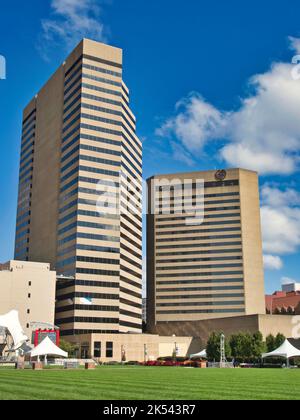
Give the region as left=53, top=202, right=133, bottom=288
left=157, top=39, right=300, bottom=175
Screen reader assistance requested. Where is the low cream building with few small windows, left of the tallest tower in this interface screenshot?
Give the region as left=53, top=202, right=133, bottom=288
left=0, top=261, right=56, bottom=339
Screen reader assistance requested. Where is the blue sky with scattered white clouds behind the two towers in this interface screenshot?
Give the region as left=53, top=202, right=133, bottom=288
left=0, top=0, right=300, bottom=293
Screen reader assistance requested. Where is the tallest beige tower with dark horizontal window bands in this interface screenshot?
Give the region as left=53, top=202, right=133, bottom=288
left=15, top=39, right=142, bottom=335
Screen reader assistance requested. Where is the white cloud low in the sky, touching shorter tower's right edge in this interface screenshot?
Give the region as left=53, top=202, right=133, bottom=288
left=261, top=185, right=300, bottom=255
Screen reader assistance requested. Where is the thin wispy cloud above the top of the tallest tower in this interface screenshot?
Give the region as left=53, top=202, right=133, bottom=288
left=39, top=0, right=105, bottom=58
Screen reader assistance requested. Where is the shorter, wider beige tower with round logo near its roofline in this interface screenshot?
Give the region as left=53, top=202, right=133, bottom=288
left=147, top=169, right=265, bottom=328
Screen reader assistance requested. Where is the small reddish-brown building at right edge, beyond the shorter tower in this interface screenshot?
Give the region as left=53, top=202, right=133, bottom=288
left=266, top=285, right=300, bottom=315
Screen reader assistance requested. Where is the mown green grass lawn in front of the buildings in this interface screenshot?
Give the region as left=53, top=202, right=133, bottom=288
left=0, top=367, right=300, bottom=400
